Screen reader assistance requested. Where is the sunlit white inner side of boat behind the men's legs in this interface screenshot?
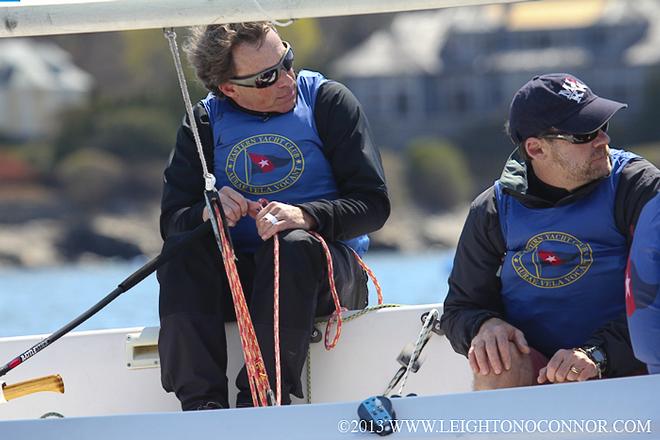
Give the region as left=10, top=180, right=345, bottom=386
left=0, top=305, right=471, bottom=420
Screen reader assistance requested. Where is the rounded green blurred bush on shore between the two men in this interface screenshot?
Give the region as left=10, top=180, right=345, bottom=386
left=405, top=138, right=473, bottom=212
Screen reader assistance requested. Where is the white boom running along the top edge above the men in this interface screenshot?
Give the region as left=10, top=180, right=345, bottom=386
left=0, top=0, right=519, bottom=37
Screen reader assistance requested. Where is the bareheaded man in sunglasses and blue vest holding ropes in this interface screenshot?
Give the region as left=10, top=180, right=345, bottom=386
left=158, top=23, right=390, bottom=410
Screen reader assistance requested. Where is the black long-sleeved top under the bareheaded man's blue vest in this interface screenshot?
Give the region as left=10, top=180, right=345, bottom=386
left=160, top=81, right=390, bottom=241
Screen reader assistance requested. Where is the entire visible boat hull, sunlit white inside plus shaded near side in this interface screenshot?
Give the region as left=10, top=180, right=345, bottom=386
left=0, top=305, right=660, bottom=440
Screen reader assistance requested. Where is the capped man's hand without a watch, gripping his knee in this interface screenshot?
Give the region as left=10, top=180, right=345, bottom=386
left=468, top=318, right=529, bottom=375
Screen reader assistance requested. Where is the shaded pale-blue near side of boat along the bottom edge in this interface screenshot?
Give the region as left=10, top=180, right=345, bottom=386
left=0, top=375, right=660, bottom=440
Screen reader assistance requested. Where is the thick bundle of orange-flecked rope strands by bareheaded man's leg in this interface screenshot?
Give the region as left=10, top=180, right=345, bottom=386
left=213, top=201, right=278, bottom=406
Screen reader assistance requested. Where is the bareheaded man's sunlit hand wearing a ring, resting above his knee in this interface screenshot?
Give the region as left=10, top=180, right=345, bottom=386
left=255, top=202, right=316, bottom=241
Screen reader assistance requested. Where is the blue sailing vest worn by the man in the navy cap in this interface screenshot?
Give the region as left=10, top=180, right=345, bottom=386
left=495, top=150, right=635, bottom=357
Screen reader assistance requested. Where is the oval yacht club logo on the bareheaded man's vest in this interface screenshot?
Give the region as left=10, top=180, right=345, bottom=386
left=225, top=134, right=305, bottom=194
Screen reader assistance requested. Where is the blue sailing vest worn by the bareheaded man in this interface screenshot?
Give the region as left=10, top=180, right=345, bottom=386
left=202, top=70, right=369, bottom=255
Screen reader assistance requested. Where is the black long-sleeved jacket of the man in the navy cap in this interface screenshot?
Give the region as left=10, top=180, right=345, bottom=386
left=441, top=150, right=660, bottom=376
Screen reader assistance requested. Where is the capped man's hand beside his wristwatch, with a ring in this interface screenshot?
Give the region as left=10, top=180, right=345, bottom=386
left=537, top=349, right=598, bottom=383
